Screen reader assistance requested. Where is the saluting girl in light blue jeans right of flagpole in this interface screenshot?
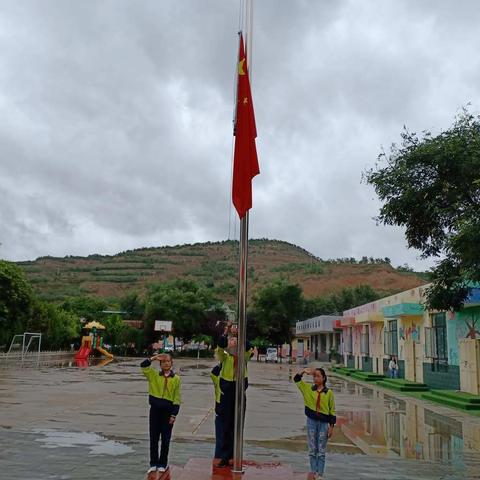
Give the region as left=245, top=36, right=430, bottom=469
left=293, top=368, right=337, bottom=479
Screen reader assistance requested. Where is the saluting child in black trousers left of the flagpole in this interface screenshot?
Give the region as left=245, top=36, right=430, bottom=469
left=140, top=353, right=180, bottom=473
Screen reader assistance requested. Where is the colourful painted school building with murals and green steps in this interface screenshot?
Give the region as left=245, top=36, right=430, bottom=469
left=340, top=285, right=480, bottom=395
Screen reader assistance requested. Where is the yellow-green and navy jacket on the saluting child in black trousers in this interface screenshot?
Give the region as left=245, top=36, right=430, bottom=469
left=140, top=359, right=181, bottom=415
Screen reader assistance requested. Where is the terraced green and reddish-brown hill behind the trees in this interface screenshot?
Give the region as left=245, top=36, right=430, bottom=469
left=18, top=239, right=426, bottom=302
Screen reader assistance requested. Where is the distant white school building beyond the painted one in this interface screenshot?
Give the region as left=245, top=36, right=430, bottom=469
left=295, top=315, right=342, bottom=362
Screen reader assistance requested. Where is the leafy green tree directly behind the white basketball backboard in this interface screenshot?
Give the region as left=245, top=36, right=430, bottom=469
left=145, top=280, right=219, bottom=343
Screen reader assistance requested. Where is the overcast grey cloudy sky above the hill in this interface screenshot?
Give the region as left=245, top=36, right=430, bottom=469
left=0, top=0, right=480, bottom=268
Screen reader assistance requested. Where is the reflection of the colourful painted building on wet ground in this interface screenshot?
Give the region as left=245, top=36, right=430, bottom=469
left=332, top=379, right=480, bottom=471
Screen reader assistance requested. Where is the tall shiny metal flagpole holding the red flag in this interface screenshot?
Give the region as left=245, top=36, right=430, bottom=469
left=233, top=0, right=253, bottom=473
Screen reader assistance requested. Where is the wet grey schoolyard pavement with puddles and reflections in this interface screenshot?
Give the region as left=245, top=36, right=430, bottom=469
left=0, top=360, right=480, bottom=480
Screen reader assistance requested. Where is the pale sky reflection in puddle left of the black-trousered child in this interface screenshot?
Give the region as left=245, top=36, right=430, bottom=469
left=34, top=430, right=133, bottom=456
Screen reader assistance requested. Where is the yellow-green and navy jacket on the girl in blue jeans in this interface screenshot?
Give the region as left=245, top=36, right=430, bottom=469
left=293, top=374, right=337, bottom=425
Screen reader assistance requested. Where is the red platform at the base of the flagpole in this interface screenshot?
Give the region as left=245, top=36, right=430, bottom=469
left=146, top=458, right=308, bottom=480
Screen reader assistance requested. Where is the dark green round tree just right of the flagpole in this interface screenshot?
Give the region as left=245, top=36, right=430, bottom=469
left=252, top=280, right=304, bottom=345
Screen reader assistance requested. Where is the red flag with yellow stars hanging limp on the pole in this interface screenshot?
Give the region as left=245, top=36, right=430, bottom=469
left=232, top=34, right=260, bottom=218
